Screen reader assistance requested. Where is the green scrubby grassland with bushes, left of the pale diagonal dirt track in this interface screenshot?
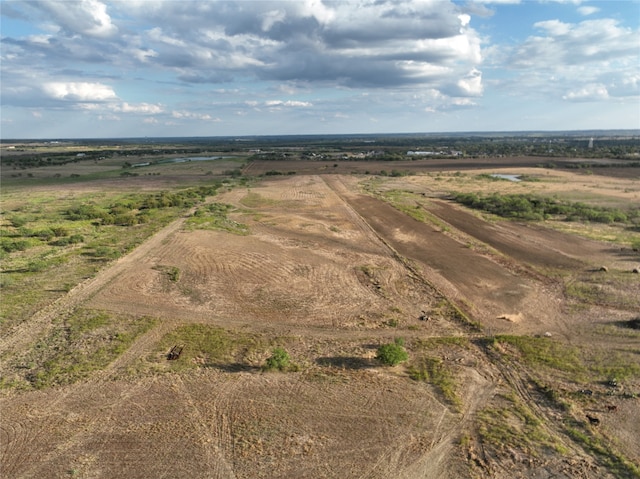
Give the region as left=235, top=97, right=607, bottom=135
left=0, top=183, right=228, bottom=331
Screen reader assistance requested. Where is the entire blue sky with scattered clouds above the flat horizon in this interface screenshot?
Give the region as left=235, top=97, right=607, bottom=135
left=0, top=0, right=640, bottom=139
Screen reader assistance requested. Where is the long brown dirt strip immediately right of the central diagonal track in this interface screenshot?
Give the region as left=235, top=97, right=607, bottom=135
left=327, top=177, right=570, bottom=335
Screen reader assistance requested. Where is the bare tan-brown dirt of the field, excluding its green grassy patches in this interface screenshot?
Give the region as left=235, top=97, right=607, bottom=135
left=0, top=162, right=640, bottom=479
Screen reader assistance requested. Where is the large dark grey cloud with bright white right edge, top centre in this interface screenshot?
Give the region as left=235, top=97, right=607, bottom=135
left=120, top=0, right=481, bottom=95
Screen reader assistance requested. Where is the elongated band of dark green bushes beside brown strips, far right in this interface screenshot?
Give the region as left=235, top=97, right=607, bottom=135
left=453, top=193, right=640, bottom=224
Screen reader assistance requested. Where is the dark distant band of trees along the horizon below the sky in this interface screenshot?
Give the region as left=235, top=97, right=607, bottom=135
left=5, top=135, right=640, bottom=169
